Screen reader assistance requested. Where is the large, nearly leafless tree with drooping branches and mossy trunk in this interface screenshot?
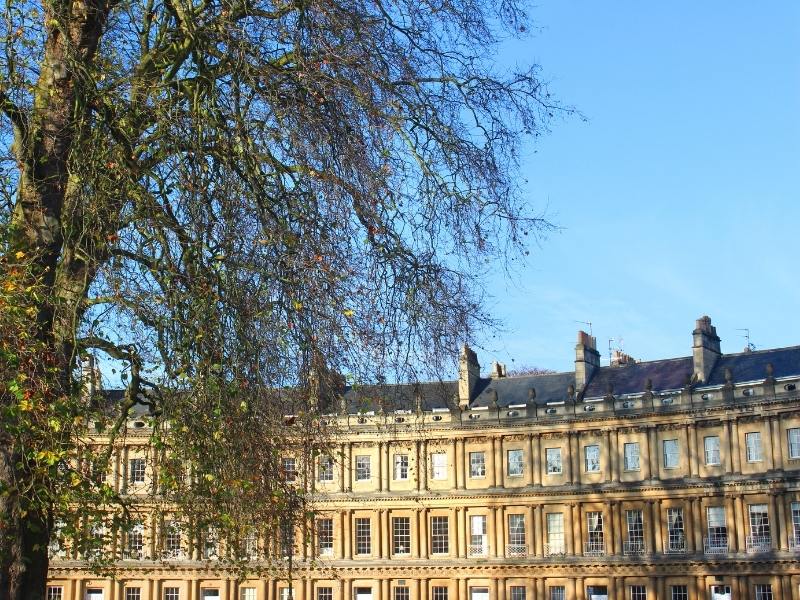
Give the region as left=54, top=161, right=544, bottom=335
left=0, top=0, right=564, bottom=600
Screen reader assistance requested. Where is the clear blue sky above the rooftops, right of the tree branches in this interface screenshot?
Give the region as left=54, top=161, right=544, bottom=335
left=477, top=0, right=800, bottom=370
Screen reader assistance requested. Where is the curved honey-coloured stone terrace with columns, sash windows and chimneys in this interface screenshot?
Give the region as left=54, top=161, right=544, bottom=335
left=48, top=317, right=800, bottom=600
